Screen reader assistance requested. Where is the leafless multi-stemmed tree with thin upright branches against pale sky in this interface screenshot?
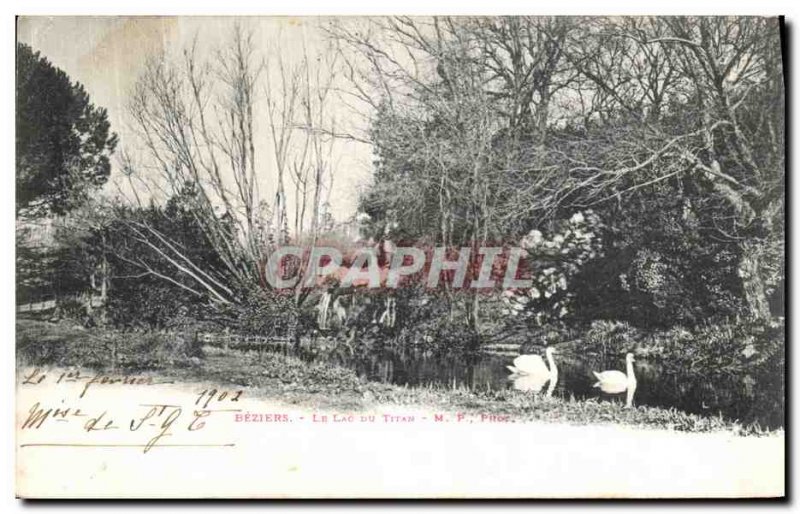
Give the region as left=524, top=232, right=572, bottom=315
left=129, top=24, right=267, bottom=303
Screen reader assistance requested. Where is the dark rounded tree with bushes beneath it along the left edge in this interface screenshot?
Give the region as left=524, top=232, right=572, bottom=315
left=16, top=43, right=117, bottom=303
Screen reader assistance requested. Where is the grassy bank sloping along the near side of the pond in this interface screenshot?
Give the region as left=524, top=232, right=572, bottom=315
left=16, top=319, right=766, bottom=435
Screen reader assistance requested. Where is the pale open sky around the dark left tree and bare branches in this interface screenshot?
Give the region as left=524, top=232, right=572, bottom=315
left=17, top=16, right=372, bottom=221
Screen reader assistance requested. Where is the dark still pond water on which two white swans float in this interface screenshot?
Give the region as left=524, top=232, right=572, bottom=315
left=316, top=349, right=784, bottom=428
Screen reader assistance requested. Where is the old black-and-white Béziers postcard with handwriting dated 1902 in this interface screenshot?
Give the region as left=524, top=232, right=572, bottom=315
left=15, top=16, right=786, bottom=498
